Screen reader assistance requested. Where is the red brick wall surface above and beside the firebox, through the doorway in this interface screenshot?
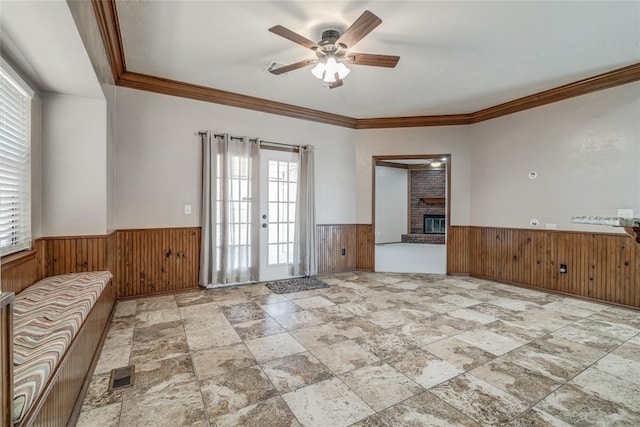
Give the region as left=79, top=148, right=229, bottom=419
left=409, top=169, right=448, bottom=234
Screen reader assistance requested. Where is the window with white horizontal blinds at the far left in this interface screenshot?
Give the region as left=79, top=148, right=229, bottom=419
left=0, top=58, right=33, bottom=255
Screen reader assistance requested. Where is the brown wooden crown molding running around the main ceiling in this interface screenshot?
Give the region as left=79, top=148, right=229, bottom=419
left=92, top=0, right=640, bottom=129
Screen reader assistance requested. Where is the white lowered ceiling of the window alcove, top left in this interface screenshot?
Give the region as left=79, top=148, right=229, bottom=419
left=0, top=0, right=104, bottom=99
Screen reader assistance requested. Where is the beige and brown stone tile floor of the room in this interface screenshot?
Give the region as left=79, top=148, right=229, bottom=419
left=78, top=272, right=640, bottom=427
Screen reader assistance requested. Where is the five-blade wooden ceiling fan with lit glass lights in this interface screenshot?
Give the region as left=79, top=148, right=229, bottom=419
left=269, top=10, right=400, bottom=89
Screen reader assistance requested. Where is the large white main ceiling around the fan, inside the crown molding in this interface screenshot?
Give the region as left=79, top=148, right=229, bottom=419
left=117, top=0, right=640, bottom=118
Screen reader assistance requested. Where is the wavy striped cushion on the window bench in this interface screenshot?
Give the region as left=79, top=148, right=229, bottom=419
left=13, top=271, right=112, bottom=423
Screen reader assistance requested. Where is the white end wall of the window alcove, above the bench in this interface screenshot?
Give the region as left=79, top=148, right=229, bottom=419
left=42, top=94, right=107, bottom=236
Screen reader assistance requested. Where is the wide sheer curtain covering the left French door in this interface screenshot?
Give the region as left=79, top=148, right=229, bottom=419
left=200, top=133, right=260, bottom=288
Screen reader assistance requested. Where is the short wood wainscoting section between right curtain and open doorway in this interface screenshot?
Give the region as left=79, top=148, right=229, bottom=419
left=316, top=224, right=358, bottom=273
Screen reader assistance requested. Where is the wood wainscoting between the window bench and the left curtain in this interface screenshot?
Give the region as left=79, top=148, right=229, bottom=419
left=115, top=227, right=201, bottom=298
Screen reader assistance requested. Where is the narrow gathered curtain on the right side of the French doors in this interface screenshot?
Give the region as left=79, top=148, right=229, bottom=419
left=291, top=145, right=318, bottom=276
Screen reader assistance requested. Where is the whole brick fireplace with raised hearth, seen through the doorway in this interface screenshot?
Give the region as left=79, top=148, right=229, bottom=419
left=402, top=169, right=447, bottom=244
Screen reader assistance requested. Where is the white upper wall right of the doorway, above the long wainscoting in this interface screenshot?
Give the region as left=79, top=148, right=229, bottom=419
left=470, top=83, right=640, bottom=232
